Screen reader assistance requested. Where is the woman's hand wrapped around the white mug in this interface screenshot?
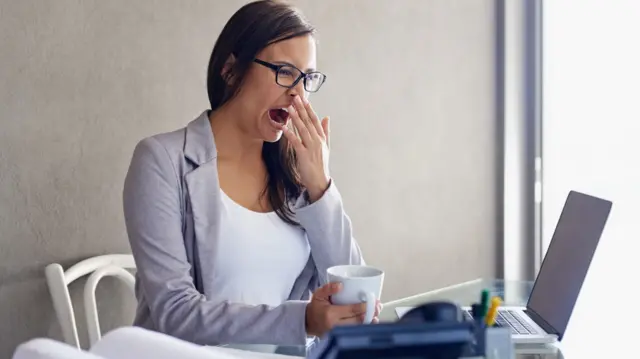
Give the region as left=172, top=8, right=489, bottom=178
left=306, top=283, right=382, bottom=337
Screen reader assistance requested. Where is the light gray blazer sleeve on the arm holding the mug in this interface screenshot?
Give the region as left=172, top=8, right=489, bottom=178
left=123, top=137, right=307, bottom=345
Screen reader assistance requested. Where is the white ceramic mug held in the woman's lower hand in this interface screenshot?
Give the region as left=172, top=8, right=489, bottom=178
left=327, top=265, right=384, bottom=324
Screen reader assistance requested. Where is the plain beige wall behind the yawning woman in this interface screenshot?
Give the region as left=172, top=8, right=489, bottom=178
left=0, top=0, right=496, bottom=357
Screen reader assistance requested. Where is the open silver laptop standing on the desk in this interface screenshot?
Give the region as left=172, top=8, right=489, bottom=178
left=396, top=191, right=612, bottom=344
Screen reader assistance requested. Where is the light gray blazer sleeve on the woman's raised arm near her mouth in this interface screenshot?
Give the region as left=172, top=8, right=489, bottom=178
left=294, top=180, right=365, bottom=285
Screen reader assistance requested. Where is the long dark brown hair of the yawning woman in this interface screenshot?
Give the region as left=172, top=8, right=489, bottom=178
left=207, top=1, right=315, bottom=225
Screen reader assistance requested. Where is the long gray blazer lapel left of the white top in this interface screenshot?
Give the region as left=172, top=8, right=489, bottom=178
left=184, top=112, right=221, bottom=296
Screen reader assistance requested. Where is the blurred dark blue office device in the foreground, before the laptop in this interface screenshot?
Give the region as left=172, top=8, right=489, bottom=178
left=309, top=302, right=514, bottom=359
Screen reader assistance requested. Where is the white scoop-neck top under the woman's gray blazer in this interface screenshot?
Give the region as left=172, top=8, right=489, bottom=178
left=212, top=190, right=310, bottom=306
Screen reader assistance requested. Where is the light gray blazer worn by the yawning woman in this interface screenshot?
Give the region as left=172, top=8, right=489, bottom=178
left=123, top=111, right=364, bottom=345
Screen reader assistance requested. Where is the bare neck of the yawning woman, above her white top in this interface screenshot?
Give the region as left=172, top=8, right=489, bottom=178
left=209, top=106, right=263, bottom=165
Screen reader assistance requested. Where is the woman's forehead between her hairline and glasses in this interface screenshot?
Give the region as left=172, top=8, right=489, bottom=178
left=258, top=35, right=316, bottom=70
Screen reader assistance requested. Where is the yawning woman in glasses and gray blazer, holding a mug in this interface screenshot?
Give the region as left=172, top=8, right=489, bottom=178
left=124, top=1, right=377, bottom=345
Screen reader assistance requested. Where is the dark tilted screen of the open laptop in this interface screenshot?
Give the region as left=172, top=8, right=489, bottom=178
left=527, top=191, right=611, bottom=338
